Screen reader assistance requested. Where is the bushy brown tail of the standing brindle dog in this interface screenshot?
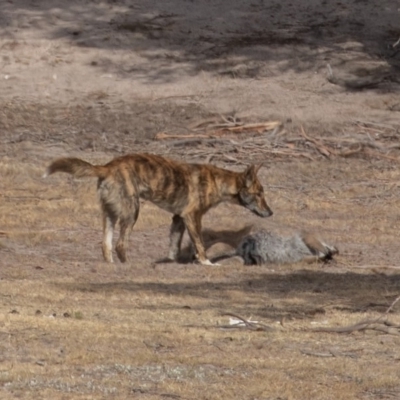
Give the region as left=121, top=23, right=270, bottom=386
left=43, top=157, right=107, bottom=178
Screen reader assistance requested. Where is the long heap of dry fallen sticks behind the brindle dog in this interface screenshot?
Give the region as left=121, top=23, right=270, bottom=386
left=149, top=116, right=400, bottom=165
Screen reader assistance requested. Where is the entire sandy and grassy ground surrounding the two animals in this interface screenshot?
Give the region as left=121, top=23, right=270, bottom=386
left=0, top=0, right=400, bottom=400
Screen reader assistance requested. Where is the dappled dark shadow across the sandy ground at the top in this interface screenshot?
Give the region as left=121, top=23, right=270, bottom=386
left=0, top=0, right=400, bottom=85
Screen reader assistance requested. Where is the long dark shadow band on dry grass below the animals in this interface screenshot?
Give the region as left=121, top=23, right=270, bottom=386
left=55, top=270, right=400, bottom=319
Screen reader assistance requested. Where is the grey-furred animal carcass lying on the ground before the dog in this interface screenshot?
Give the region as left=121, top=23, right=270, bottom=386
left=235, top=229, right=339, bottom=265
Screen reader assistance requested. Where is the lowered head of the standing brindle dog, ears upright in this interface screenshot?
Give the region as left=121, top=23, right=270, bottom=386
left=239, top=164, right=273, bottom=218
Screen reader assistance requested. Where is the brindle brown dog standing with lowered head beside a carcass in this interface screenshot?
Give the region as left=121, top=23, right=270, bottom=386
left=44, top=154, right=272, bottom=265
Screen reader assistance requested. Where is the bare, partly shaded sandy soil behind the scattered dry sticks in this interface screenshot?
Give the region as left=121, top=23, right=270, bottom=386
left=0, top=0, right=400, bottom=145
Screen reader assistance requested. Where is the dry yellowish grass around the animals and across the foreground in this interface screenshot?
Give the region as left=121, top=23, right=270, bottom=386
left=0, top=152, right=400, bottom=399
